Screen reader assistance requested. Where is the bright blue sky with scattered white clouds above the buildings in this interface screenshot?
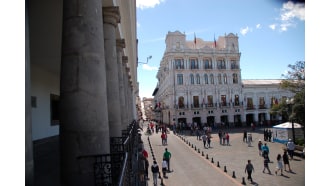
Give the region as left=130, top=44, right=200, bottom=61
left=136, top=0, right=305, bottom=98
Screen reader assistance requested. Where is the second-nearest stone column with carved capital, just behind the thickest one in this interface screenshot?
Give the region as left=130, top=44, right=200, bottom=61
left=103, top=6, right=122, bottom=137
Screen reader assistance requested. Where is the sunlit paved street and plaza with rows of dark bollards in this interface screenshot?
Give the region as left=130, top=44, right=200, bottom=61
left=142, top=124, right=305, bottom=186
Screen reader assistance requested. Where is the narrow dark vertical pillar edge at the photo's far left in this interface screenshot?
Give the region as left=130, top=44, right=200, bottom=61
left=25, top=3, right=34, bottom=186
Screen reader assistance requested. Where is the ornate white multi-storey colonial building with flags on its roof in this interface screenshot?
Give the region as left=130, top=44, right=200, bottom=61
left=153, top=31, right=293, bottom=126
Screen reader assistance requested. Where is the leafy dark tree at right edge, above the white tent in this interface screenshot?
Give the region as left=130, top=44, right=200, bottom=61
left=270, top=61, right=305, bottom=125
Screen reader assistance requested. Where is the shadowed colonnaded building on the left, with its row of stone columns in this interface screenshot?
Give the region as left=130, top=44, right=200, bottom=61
left=25, top=0, right=139, bottom=185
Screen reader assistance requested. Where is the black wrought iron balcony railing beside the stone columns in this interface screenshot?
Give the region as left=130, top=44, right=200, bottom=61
left=78, top=121, right=139, bottom=186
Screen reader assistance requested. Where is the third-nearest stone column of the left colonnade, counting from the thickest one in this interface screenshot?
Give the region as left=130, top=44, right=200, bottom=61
left=116, top=39, right=128, bottom=130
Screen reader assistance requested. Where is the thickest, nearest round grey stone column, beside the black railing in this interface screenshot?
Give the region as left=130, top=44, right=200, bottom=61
left=60, top=0, right=110, bottom=186
